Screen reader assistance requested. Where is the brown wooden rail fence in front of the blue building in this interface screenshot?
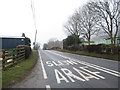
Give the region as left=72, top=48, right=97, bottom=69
left=0, top=47, right=25, bottom=70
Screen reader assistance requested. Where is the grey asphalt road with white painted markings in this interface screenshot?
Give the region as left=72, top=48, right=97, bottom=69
left=11, top=50, right=120, bottom=89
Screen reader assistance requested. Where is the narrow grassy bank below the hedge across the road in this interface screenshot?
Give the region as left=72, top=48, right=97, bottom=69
left=58, top=50, right=120, bottom=61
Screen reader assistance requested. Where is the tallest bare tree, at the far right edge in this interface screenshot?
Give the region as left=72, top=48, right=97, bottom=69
left=91, top=0, right=120, bottom=47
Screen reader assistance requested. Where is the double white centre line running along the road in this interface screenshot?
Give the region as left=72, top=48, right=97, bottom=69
left=47, top=52, right=120, bottom=77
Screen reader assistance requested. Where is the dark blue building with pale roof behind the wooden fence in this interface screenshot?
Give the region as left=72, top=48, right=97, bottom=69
left=0, top=37, right=25, bottom=50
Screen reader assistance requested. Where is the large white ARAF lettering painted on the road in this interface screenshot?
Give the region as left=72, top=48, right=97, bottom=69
left=54, top=67, right=105, bottom=84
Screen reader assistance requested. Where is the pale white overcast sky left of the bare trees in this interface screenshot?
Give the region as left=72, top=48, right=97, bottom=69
left=0, top=0, right=87, bottom=47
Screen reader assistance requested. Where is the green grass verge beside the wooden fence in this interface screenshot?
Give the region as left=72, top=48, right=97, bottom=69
left=2, top=50, right=38, bottom=88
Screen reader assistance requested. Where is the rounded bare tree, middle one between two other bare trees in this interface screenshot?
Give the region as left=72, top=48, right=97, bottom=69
left=79, top=4, right=99, bottom=45
